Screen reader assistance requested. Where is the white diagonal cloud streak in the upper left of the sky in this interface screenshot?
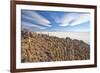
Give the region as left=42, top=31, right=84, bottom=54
left=23, top=11, right=51, bottom=27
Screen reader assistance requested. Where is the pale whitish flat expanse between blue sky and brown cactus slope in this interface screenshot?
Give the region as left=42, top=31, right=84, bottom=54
left=36, top=32, right=90, bottom=44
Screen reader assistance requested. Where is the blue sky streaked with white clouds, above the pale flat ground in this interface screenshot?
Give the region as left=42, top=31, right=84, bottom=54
left=21, top=10, right=90, bottom=32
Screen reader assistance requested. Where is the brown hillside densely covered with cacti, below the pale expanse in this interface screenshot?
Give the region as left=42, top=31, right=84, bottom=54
left=21, top=30, right=90, bottom=62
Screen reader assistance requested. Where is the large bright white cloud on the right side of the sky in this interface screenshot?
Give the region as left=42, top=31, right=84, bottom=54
left=59, top=13, right=90, bottom=26
